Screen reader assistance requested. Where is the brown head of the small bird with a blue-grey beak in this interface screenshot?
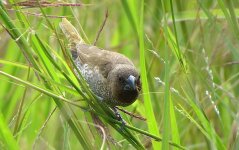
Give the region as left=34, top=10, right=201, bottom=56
left=108, top=64, right=141, bottom=106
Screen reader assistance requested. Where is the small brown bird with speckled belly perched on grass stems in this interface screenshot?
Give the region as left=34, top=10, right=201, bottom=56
left=59, top=18, right=141, bottom=118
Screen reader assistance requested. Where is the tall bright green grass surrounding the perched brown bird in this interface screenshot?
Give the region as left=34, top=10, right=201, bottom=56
left=0, top=0, right=239, bottom=150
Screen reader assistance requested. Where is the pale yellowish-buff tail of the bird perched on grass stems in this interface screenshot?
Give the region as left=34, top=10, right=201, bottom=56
left=59, top=18, right=85, bottom=51
